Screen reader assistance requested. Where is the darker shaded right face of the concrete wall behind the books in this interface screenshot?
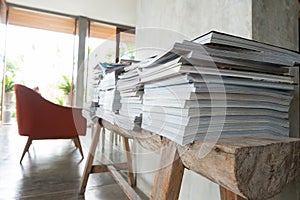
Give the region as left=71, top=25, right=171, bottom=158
left=252, top=0, right=300, bottom=141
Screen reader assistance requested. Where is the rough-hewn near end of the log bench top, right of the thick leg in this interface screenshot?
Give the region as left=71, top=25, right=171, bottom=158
left=177, top=135, right=300, bottom=199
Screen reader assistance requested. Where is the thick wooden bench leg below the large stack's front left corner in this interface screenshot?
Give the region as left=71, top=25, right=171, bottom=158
left=150, top=138, right=184, bottom=200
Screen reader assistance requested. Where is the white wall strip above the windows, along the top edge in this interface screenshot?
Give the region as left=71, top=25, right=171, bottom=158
left=7, top=0, right=136, bottom=26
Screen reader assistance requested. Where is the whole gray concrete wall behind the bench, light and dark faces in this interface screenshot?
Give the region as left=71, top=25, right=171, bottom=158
left=136, top=0, right=299, bottom=200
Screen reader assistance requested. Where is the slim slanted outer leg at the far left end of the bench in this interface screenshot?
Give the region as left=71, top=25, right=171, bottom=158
left=79, top=123, right=104, bottom=194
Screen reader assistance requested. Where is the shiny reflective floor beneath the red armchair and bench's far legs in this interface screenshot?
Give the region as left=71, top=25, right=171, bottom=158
left=0, top=123, right=147, bottom=200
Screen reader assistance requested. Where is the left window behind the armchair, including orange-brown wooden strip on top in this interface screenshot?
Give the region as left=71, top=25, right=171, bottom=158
left=6, top=6, right=75, bottom=103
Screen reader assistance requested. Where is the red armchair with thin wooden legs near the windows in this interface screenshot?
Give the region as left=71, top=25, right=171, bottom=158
left=14, top=84, right=86, bottom=163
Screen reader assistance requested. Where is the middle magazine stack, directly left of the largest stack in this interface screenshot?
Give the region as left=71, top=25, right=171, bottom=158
left=115, top=64, right=143, bottom=130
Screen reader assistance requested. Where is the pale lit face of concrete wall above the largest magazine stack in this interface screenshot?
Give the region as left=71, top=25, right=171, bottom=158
left=136, top=0, right=252, bottom=58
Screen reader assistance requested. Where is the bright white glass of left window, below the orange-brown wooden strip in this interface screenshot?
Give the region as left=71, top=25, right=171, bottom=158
left=6, top=25, right=74, bottom=103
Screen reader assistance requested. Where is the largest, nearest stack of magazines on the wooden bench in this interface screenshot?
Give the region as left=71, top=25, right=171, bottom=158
left=140, top=32, right=300, bottom=145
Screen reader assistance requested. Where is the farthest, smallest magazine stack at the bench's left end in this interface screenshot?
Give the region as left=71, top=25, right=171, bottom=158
left=96, top=70, right=121, bottom=124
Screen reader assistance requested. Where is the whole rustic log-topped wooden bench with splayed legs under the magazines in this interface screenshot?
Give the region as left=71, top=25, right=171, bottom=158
left=80, top=120, right=300, bottom=200
